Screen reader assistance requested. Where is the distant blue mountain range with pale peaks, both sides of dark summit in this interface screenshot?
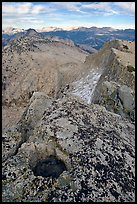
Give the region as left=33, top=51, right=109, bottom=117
left=2, top=27, right=135, bottom=53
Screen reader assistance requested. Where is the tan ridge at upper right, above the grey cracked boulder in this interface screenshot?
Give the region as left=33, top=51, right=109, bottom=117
left=85, top=40, right=135, bottom=89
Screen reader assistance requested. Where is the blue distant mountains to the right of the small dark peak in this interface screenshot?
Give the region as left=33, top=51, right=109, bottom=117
left=43, top=27, right=135, bottom=50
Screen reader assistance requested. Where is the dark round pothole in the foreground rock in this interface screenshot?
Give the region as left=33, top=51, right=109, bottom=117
left=32, top=156, right=67, bottom=178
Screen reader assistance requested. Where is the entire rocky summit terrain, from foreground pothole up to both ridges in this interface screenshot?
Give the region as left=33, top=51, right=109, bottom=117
left=2, top=29, right=135, bottom=202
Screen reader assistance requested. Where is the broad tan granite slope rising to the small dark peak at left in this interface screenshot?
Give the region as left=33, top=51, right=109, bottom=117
left=2, top=34, right=87, bottom=131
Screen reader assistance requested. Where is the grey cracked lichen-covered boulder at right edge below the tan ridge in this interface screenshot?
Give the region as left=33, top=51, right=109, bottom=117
left=91, top=81, right=135, bottom=121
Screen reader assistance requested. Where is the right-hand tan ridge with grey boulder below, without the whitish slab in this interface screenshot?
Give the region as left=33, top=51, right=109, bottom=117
left=82, top=40, right=135, bottom=120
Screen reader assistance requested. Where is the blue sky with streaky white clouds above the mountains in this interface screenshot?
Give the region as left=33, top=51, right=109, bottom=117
left=2, top=2, right=135, bottom=29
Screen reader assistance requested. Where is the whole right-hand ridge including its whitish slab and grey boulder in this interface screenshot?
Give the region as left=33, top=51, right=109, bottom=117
left=71, top=40, right=135, bottom=121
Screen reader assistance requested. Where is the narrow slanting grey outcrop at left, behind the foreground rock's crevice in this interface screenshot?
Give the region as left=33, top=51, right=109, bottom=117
left=2, top=92, right=52, bottom=161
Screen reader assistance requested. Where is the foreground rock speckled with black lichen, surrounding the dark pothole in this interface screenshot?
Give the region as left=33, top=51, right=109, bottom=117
left=2, top=93, right=135, bottom=202
